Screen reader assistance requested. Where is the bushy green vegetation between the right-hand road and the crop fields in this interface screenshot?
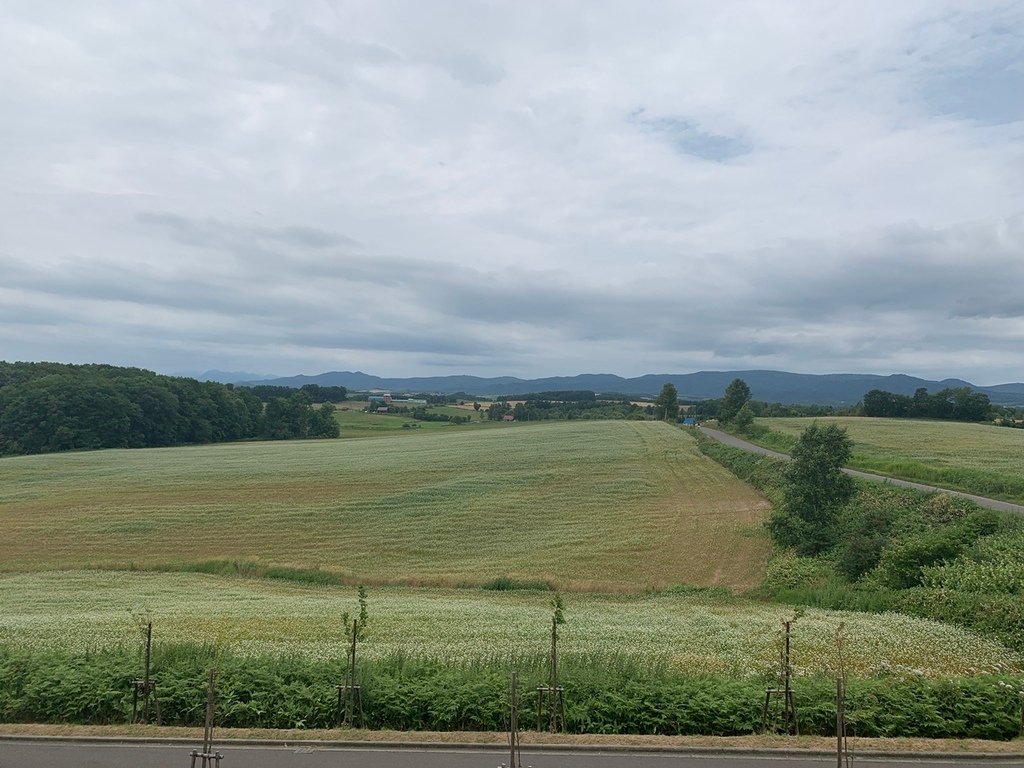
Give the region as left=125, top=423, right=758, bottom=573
left=699, top=437, right=1024, bottom=650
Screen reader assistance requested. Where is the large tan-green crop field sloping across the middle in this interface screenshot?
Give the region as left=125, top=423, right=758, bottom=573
left=0, top=421, right=768, bottom=591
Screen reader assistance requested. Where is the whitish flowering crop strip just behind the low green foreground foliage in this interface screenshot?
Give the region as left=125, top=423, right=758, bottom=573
left=0, top=571, right=1022, bottom=677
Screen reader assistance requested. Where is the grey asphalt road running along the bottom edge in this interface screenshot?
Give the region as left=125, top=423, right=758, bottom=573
left=0, top=741, right=1012, bottom=768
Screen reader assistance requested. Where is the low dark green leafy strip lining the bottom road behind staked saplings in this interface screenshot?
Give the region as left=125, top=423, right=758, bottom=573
left=0, top=644, right=1020, bottom=739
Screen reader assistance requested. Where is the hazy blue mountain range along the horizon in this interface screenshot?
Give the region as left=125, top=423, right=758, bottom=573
left=235, top=371, right=1024, bottom=406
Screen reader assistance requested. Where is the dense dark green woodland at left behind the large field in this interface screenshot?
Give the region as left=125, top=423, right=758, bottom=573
left=0, top=361, right=338, bottom=455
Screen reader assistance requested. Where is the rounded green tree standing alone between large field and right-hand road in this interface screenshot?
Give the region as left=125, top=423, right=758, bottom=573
left=768, top=422, right=854, bottom=555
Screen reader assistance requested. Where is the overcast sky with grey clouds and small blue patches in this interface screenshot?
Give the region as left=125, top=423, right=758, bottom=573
left=0, top=0, right=1024, bottom=384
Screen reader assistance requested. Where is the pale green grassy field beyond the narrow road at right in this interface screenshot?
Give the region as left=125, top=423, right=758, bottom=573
left=756, top=416, right=1024, bottom=503
